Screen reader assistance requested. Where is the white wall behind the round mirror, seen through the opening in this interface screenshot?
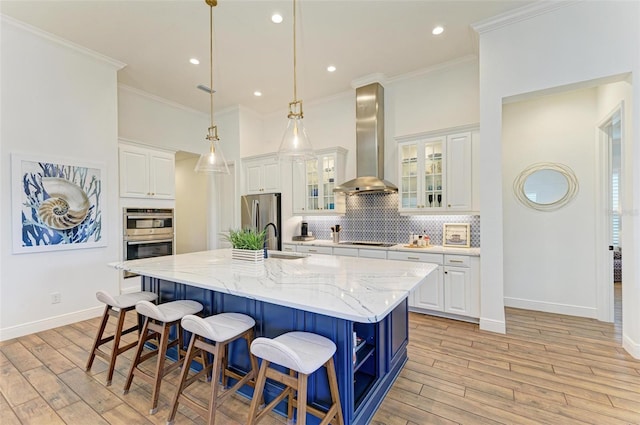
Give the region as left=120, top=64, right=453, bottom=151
left=502, top=88, right=597, bottom=318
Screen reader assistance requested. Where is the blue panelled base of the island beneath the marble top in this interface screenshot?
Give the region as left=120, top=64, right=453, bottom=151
left=142, top=276, right=408, bottom=425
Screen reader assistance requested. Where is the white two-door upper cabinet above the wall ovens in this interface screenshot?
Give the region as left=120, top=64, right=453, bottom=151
left=119, top=143, right=176, bottom=199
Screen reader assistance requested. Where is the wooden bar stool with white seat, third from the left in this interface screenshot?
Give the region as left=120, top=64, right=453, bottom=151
left=167, top=313, right=258, bottom=425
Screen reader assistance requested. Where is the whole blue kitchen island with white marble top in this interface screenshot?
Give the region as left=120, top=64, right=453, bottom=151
left=111, top=250, right=437, bottom=424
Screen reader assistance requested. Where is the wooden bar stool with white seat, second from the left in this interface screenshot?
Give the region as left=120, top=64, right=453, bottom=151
left=124, top=300, right=203, bottom=415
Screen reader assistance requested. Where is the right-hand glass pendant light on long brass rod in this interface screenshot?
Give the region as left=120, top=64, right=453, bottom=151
left=278, top=0, right=315, bottom=161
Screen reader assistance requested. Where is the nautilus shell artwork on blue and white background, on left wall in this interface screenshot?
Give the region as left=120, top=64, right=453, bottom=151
left=11, top=154, right=106, bottom=253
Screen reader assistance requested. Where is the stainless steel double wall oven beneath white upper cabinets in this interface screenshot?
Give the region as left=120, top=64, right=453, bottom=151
left=123, top=208, right=174, bottom=278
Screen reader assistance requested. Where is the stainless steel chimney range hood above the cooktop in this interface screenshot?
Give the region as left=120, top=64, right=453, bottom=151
left=333, top=83, right=398, bottom=195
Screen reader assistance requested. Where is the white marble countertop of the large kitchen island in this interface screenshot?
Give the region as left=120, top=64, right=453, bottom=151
left=109, top=249, right=438, bottom=323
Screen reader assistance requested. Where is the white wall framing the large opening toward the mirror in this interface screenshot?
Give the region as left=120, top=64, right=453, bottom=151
left=476, top=1, right=640, bottom=357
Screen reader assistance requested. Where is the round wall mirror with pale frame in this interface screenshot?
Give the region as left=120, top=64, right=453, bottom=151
left=513, top=162, right=578, bottom=211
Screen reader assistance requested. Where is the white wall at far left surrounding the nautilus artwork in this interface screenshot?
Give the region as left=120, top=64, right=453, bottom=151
left=0, top=18, right=120, bottom=340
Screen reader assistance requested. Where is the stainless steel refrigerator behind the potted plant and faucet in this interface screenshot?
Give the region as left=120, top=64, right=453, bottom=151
left=240, top=193, right=282, bottom=251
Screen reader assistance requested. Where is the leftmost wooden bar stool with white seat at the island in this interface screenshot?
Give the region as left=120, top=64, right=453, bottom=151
left=86, top=291, right=158, bottom=386
